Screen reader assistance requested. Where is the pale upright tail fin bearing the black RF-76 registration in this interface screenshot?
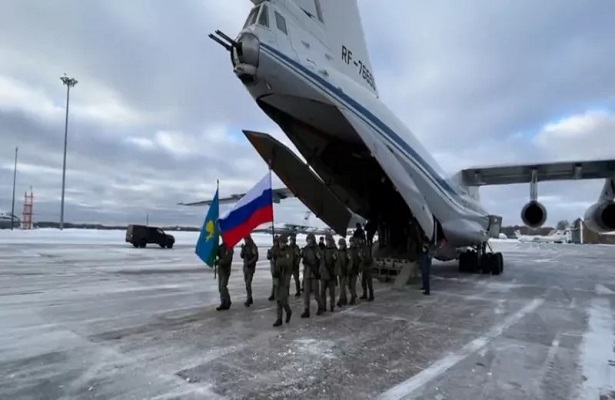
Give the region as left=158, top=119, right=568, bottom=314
left=306, top=0, right=378, bottom=97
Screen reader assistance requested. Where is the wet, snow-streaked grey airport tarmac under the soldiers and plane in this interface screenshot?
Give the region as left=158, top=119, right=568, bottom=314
left=0, top=232, right=615, bottom=400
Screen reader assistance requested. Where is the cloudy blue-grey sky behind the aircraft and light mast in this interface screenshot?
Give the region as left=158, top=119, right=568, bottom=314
left=0, top=0, right=615, bottom=225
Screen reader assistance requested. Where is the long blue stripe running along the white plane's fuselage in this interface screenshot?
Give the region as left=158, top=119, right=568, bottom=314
left=261, top=43, right=486, bottom=217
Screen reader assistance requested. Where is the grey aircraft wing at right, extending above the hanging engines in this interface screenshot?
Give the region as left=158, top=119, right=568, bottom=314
left=461, top=160, right=615, bottom=186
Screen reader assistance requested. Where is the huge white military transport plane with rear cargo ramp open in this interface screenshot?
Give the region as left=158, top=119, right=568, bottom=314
left=188, top=0, right=615, bottom=274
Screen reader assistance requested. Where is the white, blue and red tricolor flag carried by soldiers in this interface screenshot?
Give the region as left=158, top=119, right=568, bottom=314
left=218, top=171, right=273, bottom=247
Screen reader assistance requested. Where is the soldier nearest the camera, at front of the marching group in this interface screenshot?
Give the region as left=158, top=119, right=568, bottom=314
left=273, top=234, right=296, bottom=326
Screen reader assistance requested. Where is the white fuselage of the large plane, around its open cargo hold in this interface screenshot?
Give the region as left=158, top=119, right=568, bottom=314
left=224, top=0, right=499, bottom=258
